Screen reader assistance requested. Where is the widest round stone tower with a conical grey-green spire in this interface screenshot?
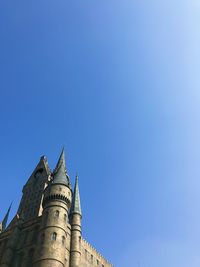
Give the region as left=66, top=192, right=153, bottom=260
left=33, top=150, right=72, bottom=267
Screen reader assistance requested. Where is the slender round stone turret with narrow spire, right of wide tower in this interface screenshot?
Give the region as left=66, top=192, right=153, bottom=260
left=70, top=176, right=82, bottom=267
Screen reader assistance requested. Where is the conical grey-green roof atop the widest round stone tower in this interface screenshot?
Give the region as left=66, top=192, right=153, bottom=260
left=53, top=148, right=70, bottom=186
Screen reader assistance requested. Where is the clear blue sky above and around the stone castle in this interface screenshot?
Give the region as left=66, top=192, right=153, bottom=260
left=0, top=0, right=200, bottom=267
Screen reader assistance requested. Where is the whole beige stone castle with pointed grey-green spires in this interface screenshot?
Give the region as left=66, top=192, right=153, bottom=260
left=0, top=150, right=111, bottom=267
